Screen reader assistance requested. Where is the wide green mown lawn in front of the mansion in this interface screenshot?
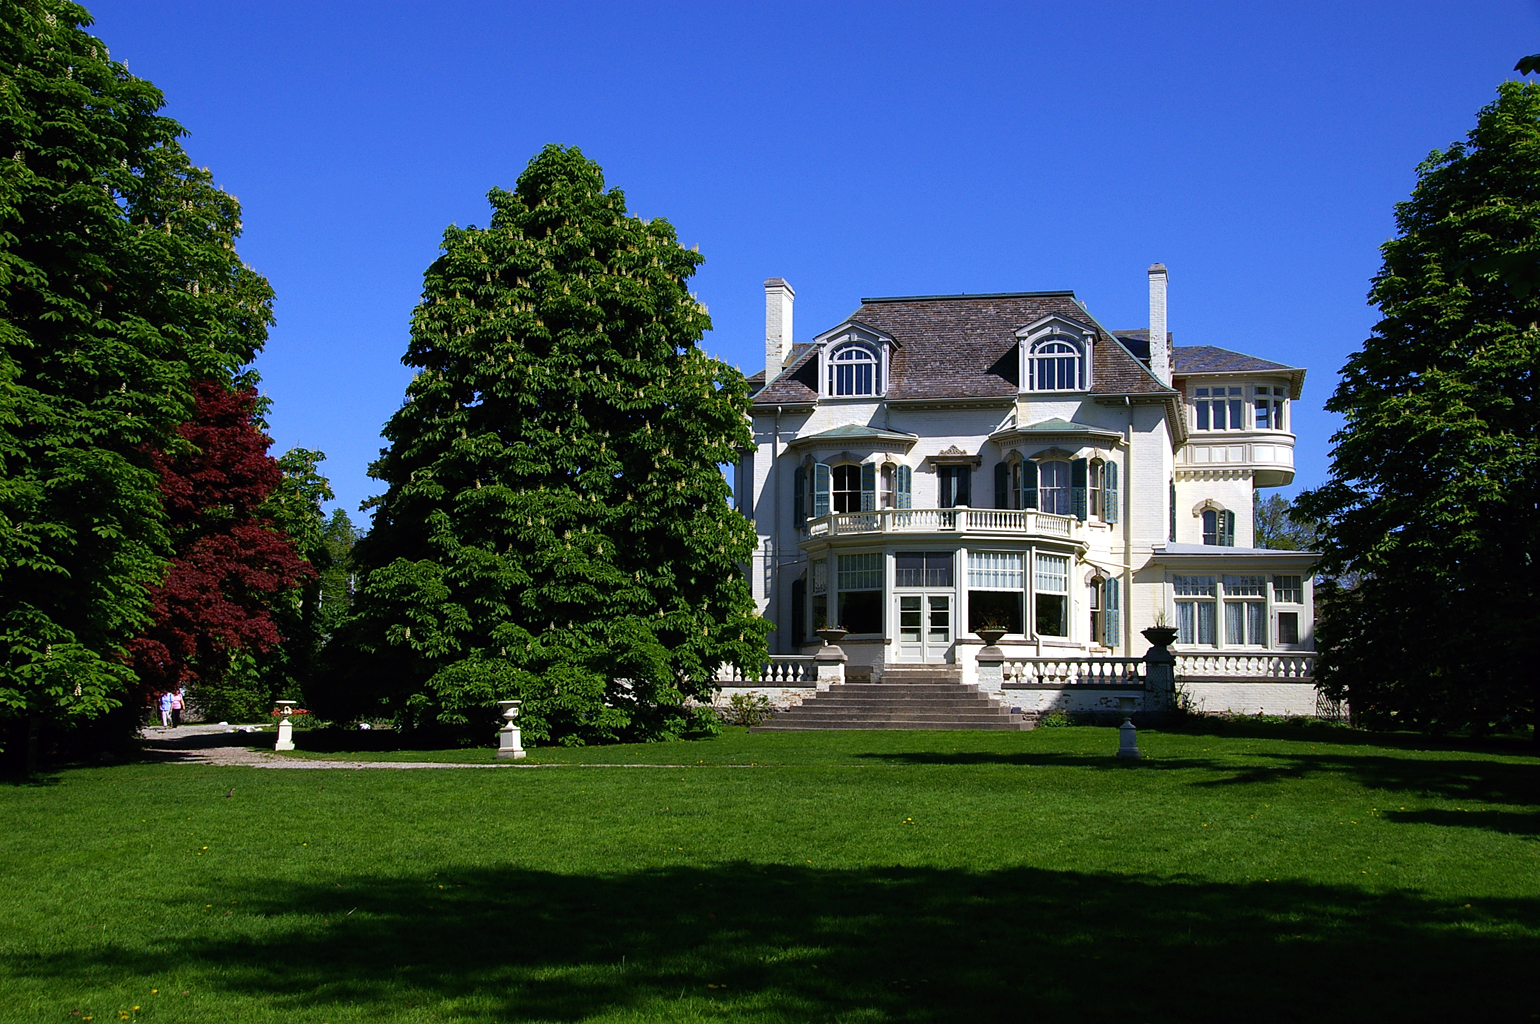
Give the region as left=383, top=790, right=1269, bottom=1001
left=0, top=725, right=1540, bottom=1024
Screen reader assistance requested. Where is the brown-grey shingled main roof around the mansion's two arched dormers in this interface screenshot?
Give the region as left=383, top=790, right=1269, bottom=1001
left=753, top=291, right=1172, bottom=405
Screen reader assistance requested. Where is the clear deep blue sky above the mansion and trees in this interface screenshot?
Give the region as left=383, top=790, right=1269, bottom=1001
left=89, top=0, right=1540, bottom=520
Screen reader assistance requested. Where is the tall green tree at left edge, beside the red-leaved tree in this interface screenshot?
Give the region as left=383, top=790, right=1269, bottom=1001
left=0, top=0, right=273, bottom=766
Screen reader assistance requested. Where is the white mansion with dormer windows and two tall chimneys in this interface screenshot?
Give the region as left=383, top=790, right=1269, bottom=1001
left=733, top=263, right=1315, bottom=714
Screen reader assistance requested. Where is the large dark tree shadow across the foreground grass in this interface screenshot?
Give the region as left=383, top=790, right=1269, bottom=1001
left=11, top=864, right=1540, bottom=1021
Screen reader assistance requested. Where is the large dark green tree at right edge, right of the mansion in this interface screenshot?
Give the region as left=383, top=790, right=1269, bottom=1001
left=1297, top=82, right=1540, bottom=730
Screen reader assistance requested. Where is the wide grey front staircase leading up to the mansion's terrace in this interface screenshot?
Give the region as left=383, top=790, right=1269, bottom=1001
left=750, top=665, right=1035, bottom=733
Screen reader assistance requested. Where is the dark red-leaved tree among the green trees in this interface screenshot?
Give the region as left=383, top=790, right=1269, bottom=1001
left=131, top=380, right=314, bottom=693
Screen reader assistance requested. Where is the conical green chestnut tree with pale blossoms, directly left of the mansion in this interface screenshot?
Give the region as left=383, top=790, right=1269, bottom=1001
left=333, top=146, right=765, bottom=742
